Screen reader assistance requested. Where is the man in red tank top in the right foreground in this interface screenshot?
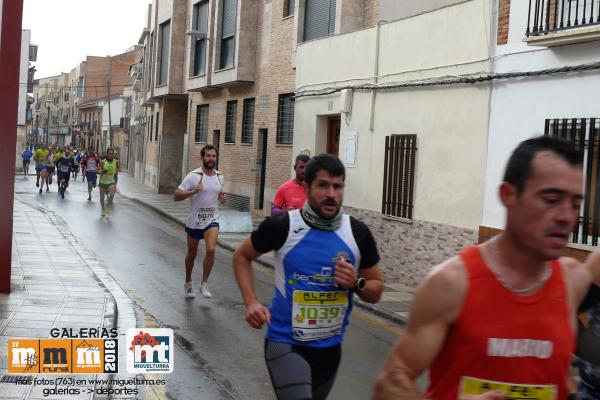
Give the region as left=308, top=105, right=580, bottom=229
left=373, top=136, right=594, bottom=400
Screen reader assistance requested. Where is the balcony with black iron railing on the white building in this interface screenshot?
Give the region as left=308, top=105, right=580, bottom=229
left=523, top=0, right=600, bottom=47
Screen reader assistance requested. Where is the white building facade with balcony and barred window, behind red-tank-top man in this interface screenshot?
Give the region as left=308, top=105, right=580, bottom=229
left=481, top=0, right=600, bottom=252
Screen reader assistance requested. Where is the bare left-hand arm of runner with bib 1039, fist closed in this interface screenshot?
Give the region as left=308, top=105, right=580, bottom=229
left=233, top=238, right=271, bottom=329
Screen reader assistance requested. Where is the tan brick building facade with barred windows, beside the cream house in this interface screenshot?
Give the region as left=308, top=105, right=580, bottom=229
left=186, top=1, right=295, bottom=213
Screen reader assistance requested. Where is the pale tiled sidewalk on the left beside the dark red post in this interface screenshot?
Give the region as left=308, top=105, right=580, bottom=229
left=0, top=195, right=136, bottom=399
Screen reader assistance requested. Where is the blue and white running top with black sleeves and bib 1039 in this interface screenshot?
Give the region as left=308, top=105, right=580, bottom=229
left=251, top=210, right=379, bottom=347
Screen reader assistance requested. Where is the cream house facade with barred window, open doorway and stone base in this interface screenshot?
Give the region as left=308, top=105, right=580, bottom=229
left=294, top=0, right=492, bottom=285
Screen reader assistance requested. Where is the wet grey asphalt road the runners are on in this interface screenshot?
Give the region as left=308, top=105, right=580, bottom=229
left=15, top=176, right=408, bottom=399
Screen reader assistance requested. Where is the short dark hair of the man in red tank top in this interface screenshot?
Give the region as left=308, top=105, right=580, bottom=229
left=504, top=136, right=583, bottom=195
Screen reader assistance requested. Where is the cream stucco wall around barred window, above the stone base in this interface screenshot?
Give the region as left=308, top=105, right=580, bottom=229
left=293, top=0, right=491, bottom=229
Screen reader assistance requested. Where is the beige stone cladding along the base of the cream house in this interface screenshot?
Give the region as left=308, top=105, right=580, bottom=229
left=344, top=206, right=477, bottom=286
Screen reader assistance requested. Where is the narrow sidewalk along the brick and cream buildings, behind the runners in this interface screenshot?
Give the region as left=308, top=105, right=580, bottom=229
left=117, top=173, right=415, bottom=324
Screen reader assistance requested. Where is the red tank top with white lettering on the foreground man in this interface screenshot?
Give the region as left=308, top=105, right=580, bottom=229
left=427, top=246, right=575, bottom=400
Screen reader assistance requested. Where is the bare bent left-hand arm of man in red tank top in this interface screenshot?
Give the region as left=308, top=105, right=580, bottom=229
left=372, top=257, right=467, bottom=400
